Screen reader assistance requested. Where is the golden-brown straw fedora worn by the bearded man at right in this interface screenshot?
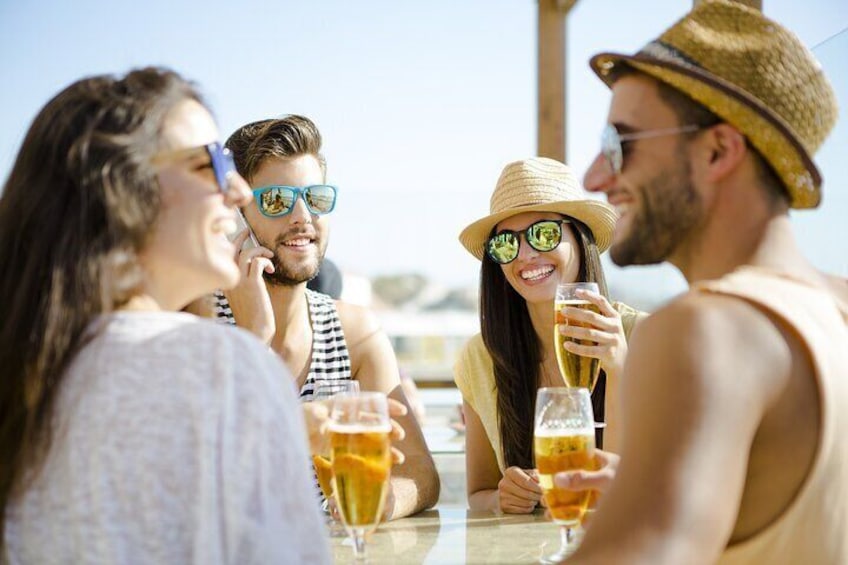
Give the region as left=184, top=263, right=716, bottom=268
left=589, top=0, right=837, bottom=208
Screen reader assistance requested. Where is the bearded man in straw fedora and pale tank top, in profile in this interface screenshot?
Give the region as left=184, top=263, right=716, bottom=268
left=556, top=0, right=848, bottom=564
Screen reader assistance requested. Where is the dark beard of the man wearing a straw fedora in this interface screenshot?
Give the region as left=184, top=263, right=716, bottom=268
left=610, top=151, right=704, bottom=267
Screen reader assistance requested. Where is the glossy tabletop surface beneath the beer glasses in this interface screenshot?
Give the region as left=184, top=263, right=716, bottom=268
left=332, top=506, right=559, bottom=564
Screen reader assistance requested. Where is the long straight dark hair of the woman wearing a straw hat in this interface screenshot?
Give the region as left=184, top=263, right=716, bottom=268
left=480, top=218, right=607, bottom=469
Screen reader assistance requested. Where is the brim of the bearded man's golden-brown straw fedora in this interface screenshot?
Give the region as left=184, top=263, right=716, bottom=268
left=589, top=53, right=822, bottom=208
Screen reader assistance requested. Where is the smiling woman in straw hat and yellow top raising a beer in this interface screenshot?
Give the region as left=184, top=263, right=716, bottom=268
left=454, top=158, right=638, bottom=513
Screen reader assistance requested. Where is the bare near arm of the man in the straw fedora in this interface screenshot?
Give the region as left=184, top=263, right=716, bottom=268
left=569, top=295, right=791, bottom=564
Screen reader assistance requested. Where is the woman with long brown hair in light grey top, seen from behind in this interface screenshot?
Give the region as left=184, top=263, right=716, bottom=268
left=0, top=68, right=329, bottom=564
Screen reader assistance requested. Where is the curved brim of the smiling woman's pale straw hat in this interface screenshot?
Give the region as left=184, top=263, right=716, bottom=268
left=459, top=200, right=618, bottom=261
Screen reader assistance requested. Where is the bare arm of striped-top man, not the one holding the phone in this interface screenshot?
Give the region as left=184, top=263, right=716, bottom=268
left=337, top=302, right=440, bottom=518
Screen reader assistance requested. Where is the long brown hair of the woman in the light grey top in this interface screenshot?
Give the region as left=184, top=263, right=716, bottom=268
left=0, top=68, right=200, bottom=550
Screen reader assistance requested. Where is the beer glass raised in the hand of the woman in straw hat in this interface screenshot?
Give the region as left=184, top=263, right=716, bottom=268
left=554, top=282, right=601, bottom=392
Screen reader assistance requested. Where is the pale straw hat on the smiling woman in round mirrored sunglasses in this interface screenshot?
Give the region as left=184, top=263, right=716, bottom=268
left=459, top=157, right=618, bottom=260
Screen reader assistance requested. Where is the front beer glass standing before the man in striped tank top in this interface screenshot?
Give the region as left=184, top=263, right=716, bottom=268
left=330, top=392, right=392, bottom=559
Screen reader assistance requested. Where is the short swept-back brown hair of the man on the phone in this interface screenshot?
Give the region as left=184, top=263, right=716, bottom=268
left=226, top=115, right=327, bottom=182
